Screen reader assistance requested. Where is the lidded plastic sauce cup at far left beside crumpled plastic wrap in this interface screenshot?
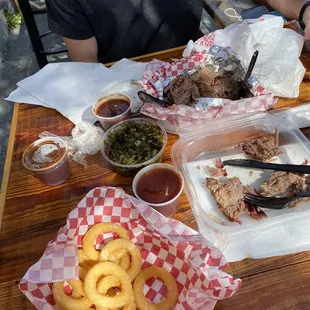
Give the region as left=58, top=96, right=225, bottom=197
left=22, top=137, right=71, bottom=186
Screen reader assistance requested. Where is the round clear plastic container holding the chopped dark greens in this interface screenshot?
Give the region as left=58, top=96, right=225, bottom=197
left=101, top=118, right=168, bottom=176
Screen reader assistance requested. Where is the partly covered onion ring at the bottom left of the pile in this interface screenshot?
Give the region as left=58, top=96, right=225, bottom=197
left=52, top=281, right=92, bottom=310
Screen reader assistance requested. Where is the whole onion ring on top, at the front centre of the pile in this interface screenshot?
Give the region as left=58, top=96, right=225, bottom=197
left=84, top=262, right=133, bottom=308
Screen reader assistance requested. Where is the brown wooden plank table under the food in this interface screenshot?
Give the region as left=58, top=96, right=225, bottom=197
left=0, top=42, right=310, bottom=310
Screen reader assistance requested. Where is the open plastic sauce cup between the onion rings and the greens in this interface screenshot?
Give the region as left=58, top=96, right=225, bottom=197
left=132, top=164, right=184, bottom=217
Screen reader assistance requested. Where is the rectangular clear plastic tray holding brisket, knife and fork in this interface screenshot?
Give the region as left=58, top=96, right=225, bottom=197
left=171, top=113, right=310, bottom=250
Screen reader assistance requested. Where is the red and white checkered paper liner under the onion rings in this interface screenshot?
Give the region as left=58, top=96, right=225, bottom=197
left=20, top=187, right=241, bottom=310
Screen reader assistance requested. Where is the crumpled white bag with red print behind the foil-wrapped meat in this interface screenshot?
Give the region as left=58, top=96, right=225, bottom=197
left=183, top=15, right=306, bottom=98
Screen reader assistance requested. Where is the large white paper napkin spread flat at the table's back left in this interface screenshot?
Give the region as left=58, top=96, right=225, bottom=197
left=6, top=59, right=146, bottom=124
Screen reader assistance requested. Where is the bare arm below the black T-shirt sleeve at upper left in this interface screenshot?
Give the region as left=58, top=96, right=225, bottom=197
left=62, top=37, right=98, bottom=62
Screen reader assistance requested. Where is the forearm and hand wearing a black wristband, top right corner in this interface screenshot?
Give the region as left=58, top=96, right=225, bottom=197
left=267, top=0, right=310, bottom=39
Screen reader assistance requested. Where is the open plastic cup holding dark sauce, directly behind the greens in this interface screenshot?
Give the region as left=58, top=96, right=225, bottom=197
left=93, top=94, right=132, bottom=130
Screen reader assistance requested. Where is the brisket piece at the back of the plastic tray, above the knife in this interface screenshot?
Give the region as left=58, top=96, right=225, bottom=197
left=241, top=129, right=280, bottom=161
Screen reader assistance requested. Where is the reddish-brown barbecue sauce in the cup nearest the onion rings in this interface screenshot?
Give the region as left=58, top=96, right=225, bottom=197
left=137, top=168, right=181, bottom=204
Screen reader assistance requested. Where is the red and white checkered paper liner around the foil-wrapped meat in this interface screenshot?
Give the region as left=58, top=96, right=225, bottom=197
left=141, top=32, right=276, bottom=126
